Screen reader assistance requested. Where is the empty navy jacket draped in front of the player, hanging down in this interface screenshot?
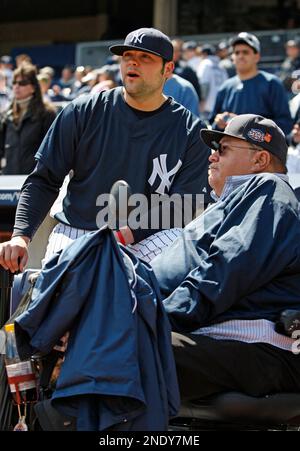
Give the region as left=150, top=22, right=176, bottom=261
left=16, top=229, right=179, bottom=430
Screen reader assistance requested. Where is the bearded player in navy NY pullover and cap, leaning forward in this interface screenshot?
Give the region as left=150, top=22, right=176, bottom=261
left=0, top=28, right=209, bottom=272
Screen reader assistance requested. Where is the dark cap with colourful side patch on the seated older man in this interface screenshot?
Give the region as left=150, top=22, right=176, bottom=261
left=200, top=114, right=288, bottom=165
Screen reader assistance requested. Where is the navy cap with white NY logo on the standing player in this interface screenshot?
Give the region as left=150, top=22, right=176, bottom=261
left=109, top=28, right=173, bottom=61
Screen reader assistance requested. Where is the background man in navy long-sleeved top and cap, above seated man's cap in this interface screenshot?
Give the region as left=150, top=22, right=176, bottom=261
left=210, top=32, right=292, bottom=134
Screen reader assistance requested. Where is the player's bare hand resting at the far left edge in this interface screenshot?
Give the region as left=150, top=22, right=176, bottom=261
left=0, top=236, right=30, bottom=273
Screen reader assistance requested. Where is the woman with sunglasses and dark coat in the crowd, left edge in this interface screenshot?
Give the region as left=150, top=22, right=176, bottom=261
left=0, top=64, right=55, bottom=175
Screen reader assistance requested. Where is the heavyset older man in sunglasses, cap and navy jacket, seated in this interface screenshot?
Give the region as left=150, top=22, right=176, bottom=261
left=153, top=114, right=300, bottom=399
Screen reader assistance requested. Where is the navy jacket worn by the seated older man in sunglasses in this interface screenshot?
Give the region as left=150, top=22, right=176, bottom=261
left=151, top=174, right=300, bottom=333
